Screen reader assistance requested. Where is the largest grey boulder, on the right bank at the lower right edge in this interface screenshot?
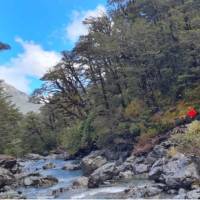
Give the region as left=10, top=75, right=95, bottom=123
left=149, top=154, right=200, bottom=189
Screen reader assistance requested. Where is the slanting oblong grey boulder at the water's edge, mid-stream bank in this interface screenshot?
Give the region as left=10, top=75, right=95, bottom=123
left=88, top=162, right=119, bottom=188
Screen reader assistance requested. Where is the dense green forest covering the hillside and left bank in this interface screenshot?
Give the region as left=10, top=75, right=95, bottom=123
left=0, top=0, right=200, bottom=156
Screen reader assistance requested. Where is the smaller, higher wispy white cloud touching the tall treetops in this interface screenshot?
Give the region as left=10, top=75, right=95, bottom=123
left=65, top=5, right=106, bottom=42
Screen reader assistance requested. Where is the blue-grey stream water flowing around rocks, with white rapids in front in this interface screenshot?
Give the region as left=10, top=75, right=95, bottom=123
left=17, top=159, right=152, bottom=199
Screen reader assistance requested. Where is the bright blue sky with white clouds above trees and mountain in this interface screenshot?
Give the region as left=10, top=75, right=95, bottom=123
left=0, top=0, right=106, bottom=94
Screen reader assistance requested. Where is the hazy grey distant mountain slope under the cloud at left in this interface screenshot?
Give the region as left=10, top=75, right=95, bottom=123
left=0, top=81, right=41, bottom=114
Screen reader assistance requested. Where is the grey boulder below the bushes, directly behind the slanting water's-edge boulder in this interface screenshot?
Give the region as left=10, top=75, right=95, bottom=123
left=81, top=151, right=107, bottom=175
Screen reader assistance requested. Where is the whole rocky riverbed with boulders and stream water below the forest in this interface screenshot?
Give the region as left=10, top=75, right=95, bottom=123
left=0, top=126, right=200, bottom=199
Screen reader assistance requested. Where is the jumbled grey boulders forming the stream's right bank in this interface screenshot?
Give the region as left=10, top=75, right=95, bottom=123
left=78, top=138, right=200, bottom=199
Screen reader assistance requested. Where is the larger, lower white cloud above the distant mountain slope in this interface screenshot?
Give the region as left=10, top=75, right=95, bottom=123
left=0, top=38, right=61, bottom=92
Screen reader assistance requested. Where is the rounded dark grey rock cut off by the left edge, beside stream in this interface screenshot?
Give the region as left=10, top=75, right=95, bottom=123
left=0, top=168, right=16, bottom=188
